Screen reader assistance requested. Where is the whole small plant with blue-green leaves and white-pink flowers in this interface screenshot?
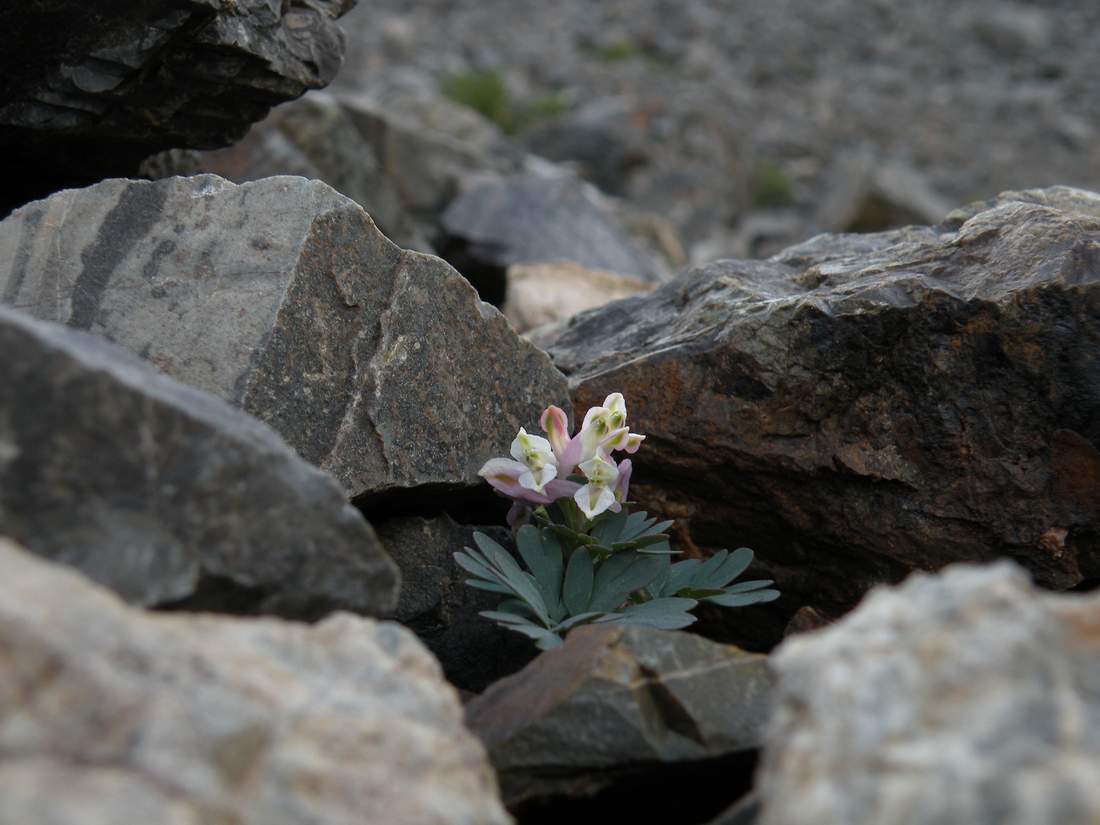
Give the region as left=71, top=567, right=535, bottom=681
left=454, top=393, right=779, bottom=649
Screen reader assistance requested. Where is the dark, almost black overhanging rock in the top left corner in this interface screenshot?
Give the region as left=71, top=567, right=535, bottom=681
left=0, top=0, right=355, bottom=215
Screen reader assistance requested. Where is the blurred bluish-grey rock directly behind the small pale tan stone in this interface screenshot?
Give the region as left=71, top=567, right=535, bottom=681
left=442, top=175, right=656, bottom=301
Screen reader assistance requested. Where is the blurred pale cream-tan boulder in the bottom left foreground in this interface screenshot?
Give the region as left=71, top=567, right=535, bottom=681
left=0, top=539, right=510, bottom=825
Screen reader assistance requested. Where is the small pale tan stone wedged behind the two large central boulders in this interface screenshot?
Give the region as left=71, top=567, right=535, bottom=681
left=501, top=263, right=653, bottom=332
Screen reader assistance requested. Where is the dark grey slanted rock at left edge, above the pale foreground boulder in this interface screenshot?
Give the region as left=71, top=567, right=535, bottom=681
left=0, top=307, right=398, bottom=617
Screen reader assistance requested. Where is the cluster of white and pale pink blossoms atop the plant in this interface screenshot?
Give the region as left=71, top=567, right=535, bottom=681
left=479, top=393, right=646, bottom=524
